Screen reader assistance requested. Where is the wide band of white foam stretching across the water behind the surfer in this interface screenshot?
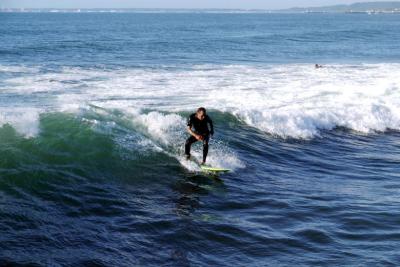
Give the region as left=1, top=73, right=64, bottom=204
left=0, top=63, right=400, bottom=140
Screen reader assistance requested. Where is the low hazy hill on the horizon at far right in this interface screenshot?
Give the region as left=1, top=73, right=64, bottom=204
left=280, top=1, right=400, bottom=13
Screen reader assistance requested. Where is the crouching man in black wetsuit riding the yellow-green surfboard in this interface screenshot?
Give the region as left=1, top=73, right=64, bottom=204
left=185, top=108, right=214, bottom=165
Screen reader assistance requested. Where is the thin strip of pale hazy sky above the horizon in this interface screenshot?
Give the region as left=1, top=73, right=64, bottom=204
left=0, top=0, right=398, bottom=9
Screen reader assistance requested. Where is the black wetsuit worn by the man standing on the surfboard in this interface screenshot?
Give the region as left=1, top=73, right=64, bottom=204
left=185, top=113, right=214, bottom=162
